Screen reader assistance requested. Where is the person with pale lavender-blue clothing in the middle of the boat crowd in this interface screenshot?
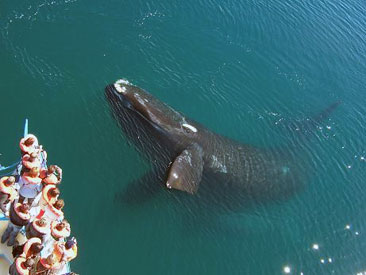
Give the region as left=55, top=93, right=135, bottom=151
left=19, top=167, right=42, bottom=206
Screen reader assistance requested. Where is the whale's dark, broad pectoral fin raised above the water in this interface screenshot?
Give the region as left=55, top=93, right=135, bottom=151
left=166, top=144, right=203, bottom=194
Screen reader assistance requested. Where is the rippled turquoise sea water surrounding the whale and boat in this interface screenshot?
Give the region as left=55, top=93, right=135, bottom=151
left=0, top=0, right=366, bottom=275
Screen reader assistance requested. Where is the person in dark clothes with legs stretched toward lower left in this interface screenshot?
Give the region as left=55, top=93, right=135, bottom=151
left=1, top=204, right=31, bottom=246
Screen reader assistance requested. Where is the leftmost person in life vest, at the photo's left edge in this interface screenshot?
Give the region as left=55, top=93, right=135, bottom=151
left=0, top=176, right=18, bottom=216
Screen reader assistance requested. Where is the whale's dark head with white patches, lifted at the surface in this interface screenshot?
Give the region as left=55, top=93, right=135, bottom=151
left=105, top=79, right=199, bottom=156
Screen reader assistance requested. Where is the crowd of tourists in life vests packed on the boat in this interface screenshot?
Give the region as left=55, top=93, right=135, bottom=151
left=0, top=134, right=77, bottom=275
